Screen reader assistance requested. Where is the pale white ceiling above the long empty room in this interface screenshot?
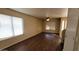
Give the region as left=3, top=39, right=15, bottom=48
left=12, top=8, right=68, bottom=18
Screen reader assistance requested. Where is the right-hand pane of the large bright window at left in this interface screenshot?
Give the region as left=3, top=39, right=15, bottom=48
left=13, top=17, right=23, bottom=36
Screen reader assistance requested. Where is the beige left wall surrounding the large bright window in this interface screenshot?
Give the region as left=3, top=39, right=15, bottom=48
left=0, top=9, right=42, bottom=49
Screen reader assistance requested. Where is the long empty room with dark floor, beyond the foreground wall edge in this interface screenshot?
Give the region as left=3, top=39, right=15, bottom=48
left=0, top=8, right=68, bottom=51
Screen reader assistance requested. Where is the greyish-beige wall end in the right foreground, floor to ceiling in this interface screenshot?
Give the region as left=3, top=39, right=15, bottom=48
left=63, top=8, right=79, bottom=51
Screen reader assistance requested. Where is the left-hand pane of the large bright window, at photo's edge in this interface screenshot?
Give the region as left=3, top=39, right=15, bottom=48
left=0, top=14, right=13, bottom=38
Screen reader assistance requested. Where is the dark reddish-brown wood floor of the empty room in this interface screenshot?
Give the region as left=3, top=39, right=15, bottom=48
left=5, top=33, right=62, bottom=51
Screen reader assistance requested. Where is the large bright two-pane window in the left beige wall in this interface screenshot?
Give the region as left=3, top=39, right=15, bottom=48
left=0, top=14, right=23, bottom=38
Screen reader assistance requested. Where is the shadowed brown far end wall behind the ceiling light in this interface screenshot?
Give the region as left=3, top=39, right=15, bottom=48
left=43, top=18, right=60, bottom=33
